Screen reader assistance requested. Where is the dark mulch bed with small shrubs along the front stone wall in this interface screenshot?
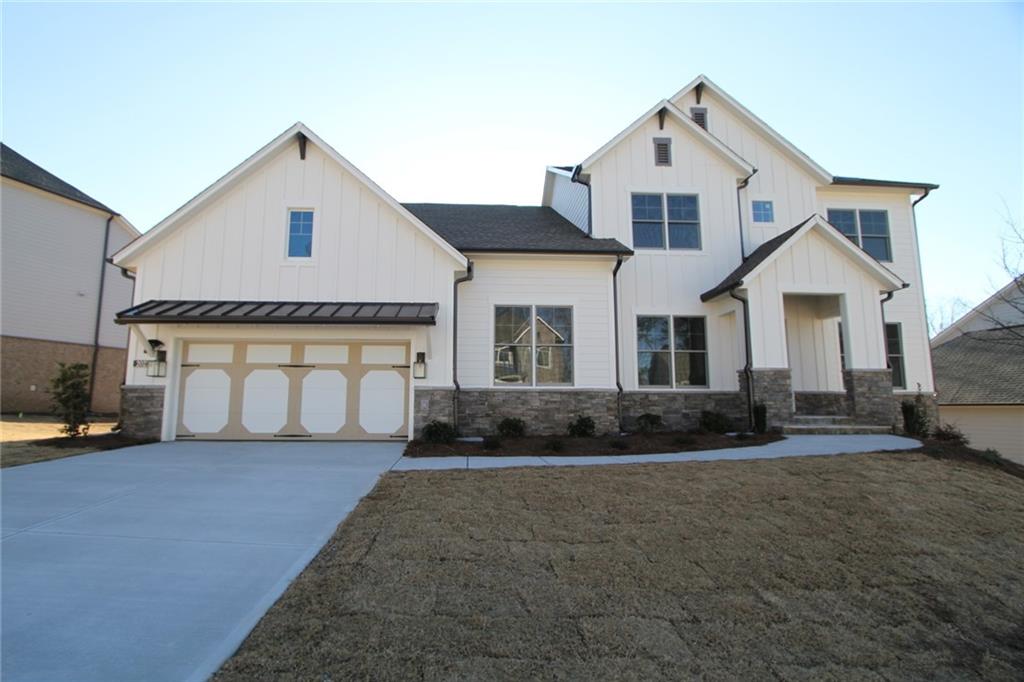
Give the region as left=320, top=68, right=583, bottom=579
left=406, top=431, right=782, bottom=457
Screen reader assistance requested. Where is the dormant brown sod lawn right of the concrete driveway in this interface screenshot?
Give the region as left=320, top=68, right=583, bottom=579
left=215, top=446, right=1024, bottom=682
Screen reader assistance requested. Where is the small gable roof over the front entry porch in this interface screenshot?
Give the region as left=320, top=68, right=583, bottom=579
left=700, top=213, right=906, bottom=302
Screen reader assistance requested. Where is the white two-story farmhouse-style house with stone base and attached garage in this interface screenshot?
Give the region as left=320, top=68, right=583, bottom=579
left=114, top=76, right=936, bottom=439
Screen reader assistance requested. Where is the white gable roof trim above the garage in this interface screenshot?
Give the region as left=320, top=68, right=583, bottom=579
left=113, top=122, right=467, bottom=266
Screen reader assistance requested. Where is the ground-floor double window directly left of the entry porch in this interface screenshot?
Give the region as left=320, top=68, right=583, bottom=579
left=637, top=316, right=708, bottom=388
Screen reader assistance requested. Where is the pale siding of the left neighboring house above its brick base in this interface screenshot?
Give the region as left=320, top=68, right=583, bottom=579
left=0, top=178, right=132, bottom=348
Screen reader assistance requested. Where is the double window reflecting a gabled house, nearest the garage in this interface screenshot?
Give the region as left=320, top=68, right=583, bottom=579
left=495, top=305, right=572, bottom=386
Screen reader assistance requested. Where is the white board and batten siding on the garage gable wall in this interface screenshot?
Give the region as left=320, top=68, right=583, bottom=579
left=129, top=138, right=460, bottom=386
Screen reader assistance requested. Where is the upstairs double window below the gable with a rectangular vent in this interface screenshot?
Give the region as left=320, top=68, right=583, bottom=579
left=632, top=195, right=700, bottom=250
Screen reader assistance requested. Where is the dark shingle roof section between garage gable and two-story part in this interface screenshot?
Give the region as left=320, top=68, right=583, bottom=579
left=402, top=204, right=633, bottom=255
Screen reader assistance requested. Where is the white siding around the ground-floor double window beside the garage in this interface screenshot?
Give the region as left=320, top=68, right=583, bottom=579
left=458, top=256, right=615, bottom=389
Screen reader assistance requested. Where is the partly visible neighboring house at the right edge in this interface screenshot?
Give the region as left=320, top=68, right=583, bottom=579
left=932, top=278, right=1024, bottom=464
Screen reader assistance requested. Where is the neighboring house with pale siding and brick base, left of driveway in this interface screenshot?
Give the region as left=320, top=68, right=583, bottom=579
left=0, top=144, right=138, bottom=414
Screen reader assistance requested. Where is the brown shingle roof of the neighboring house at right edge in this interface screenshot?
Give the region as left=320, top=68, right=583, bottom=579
left=932, top=327, right=1024, bottom=404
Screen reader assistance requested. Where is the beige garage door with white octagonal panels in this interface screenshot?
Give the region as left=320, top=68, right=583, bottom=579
left=176, top=341, right=410, bottom=440
